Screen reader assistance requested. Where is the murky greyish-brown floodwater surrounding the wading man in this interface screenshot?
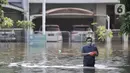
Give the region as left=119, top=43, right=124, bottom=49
left=0, top=42, right=130, bottom=73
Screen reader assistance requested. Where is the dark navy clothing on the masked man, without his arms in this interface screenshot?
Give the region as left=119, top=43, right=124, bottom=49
left=82, top=44, right=98, bottom=67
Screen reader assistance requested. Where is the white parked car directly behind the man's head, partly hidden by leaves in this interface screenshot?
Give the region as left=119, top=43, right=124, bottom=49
left=71, top=25, right=95, bottom=42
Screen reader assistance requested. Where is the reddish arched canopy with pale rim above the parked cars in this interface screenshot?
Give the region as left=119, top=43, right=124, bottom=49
left=46, top=7, right=94, bottom=16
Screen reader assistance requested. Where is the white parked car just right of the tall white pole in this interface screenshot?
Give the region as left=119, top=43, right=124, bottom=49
left=46, top=25, right=62, bottom=41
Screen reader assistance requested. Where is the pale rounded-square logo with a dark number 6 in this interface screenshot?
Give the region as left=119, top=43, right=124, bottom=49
left=115, top=4, right=125, bottom=15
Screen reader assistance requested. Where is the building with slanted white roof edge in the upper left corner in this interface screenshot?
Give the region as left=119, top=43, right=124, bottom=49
left=3, top=0, right=26, bottom=21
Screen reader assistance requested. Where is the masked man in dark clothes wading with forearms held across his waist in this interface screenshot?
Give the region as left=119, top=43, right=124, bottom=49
left=82, top=37, right=98, bottom=67
